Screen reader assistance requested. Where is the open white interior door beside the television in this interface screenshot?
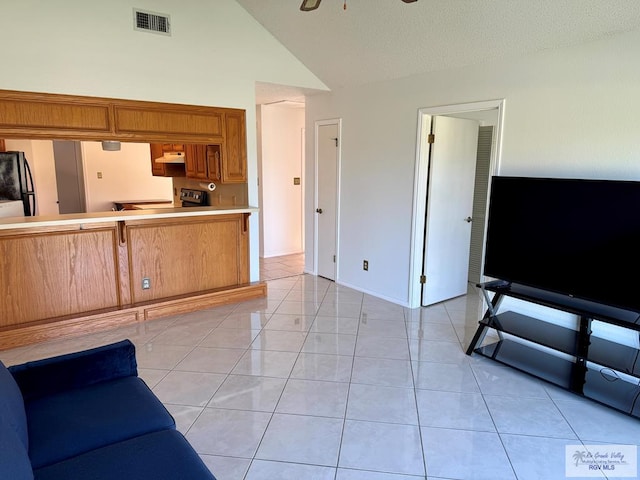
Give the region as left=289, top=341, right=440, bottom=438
left=421, top=116, right=479, bottom=306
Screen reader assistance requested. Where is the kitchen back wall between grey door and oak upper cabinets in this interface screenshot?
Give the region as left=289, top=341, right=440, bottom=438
left=81, top=142, right=173, bottom=212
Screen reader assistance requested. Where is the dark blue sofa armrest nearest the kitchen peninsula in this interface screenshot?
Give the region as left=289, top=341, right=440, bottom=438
left=9, top=340, right=138, bottom=401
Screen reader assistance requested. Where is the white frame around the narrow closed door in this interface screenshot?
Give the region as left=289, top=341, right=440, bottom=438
left=312, top=118, right=342, bottom=282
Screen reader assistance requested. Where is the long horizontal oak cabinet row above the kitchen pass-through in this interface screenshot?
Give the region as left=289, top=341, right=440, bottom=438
left=0, top=90, right=246, bottom=144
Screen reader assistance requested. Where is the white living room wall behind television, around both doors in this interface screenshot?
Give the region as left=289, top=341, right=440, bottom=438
left=305, top=31, right=640, bottom=305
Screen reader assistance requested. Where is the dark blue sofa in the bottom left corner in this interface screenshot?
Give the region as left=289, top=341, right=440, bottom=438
left=0, top=340, right=215, bottom=480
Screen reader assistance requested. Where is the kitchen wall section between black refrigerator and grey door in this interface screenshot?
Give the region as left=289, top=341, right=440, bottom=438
left=5, top=139, right=59, bottom=215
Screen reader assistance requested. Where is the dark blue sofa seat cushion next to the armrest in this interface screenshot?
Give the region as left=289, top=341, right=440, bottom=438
left=25, top=377, right=175, bottom=469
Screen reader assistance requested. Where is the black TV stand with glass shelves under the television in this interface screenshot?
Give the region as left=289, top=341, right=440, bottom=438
left=466, top=281, right=640, bottom=418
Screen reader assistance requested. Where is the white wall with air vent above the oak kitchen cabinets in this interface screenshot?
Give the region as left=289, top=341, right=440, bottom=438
left=0, top=0, right=326, bottom=280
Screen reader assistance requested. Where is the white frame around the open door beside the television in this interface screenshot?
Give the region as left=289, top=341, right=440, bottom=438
left=409, top=99, right=505, bottom=308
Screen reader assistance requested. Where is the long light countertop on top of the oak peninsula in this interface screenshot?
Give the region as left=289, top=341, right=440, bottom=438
left=0, top=206, right=259, bottom=230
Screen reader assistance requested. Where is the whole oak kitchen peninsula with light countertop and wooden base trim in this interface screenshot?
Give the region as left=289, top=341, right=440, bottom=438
left=0, top=206, right=266, bottom=349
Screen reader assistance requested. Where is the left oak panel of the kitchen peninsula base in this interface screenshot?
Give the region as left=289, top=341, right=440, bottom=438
left=0, top=223, right=121, bottom=329
